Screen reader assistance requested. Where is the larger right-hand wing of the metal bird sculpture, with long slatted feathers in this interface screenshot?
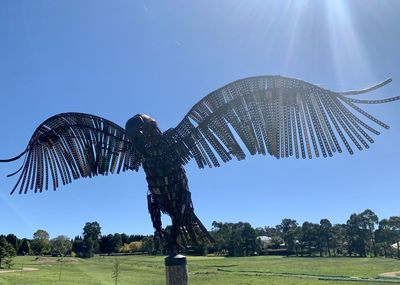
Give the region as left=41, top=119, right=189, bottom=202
left=166, top=76, right=400, bottom=168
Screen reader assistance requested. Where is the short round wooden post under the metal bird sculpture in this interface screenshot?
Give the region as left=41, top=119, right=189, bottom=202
left=165, top=254, right=189, bottom=285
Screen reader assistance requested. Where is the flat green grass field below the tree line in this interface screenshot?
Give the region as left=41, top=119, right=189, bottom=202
left=0, top=256, right=400, bottom=285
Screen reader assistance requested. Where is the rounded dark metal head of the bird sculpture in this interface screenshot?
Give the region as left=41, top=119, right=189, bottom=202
left=125, top=114, right=161, bottom=142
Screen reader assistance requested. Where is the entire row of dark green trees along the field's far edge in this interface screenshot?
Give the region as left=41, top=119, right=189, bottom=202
left=0, top=209, right=400, bottom=267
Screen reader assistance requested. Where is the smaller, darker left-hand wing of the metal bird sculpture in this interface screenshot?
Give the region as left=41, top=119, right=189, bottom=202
left=0, top=113, right=142, bottom=193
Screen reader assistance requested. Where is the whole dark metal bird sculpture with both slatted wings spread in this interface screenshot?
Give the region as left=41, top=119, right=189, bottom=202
left=0, top=76, right=400, bottom=253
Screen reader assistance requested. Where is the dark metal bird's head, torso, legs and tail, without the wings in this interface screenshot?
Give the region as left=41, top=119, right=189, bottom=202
left=125, top=114, right=212, bottom=252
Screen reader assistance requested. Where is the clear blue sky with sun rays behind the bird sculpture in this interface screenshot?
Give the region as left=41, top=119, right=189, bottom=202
left=0, top=0, right=400, bottom=237
